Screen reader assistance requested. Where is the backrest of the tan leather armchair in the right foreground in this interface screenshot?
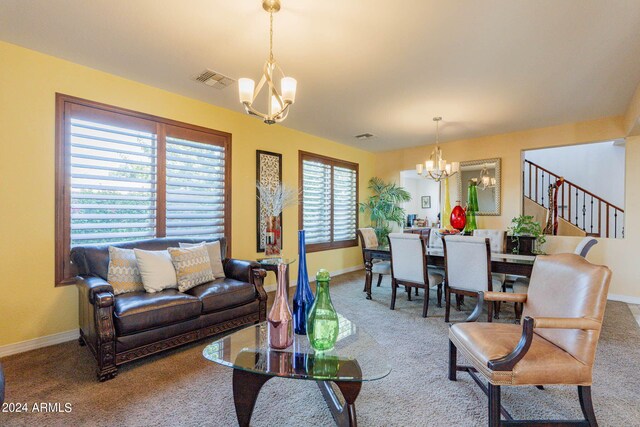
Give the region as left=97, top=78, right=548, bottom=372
left=522, top=254, right=611, bottom=367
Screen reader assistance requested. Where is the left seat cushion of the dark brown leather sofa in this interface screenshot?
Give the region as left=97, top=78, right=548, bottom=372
left=114, top=289, right=202, bottom=335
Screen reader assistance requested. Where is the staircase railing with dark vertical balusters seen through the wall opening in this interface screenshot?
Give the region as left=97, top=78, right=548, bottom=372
left=522, top=160, right=624, bottom=238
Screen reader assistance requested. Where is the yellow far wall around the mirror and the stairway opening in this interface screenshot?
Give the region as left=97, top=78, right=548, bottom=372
left=376, top=114, right=640, bottom=301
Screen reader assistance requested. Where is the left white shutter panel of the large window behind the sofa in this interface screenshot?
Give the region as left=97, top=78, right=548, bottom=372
left=70, top=118, right=157, bottom=246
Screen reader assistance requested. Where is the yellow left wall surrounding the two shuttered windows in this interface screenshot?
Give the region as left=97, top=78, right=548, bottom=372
left=0, top=42, right=374, bottom=346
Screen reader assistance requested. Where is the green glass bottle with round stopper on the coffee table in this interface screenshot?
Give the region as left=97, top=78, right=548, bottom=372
left=307, top=269, right=339, bottom=351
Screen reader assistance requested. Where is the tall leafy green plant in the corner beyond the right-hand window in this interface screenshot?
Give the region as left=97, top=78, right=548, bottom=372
left=360, top=177, right=411, bottom=245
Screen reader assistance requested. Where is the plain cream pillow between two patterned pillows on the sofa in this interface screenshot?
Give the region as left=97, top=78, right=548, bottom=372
left=133, top=249, right=178, bottom=293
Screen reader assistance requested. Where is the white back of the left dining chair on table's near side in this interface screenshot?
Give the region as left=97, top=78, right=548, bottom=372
left=389, top=233, right=428, bottom=285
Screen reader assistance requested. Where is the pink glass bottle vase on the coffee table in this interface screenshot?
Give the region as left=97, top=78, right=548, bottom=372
left=267, top=263, right=293, bottom=350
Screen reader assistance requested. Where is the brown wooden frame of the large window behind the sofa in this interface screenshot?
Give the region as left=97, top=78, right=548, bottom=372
left=55, top=93, right=231, bottom=286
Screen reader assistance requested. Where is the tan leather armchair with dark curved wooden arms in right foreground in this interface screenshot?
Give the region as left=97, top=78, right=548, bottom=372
left=449, top=254, right=611, bottom=427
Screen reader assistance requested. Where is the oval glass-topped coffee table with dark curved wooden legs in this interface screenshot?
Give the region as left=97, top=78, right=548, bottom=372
left=203, top=315, right=391, bottom=427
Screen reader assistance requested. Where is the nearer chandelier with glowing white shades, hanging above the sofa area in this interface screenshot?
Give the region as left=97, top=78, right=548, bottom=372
left=238, top=0, right=297, bottom=125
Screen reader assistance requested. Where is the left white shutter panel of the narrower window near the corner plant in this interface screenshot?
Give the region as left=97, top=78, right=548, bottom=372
left=302, top=160, right=331, bottom=244
